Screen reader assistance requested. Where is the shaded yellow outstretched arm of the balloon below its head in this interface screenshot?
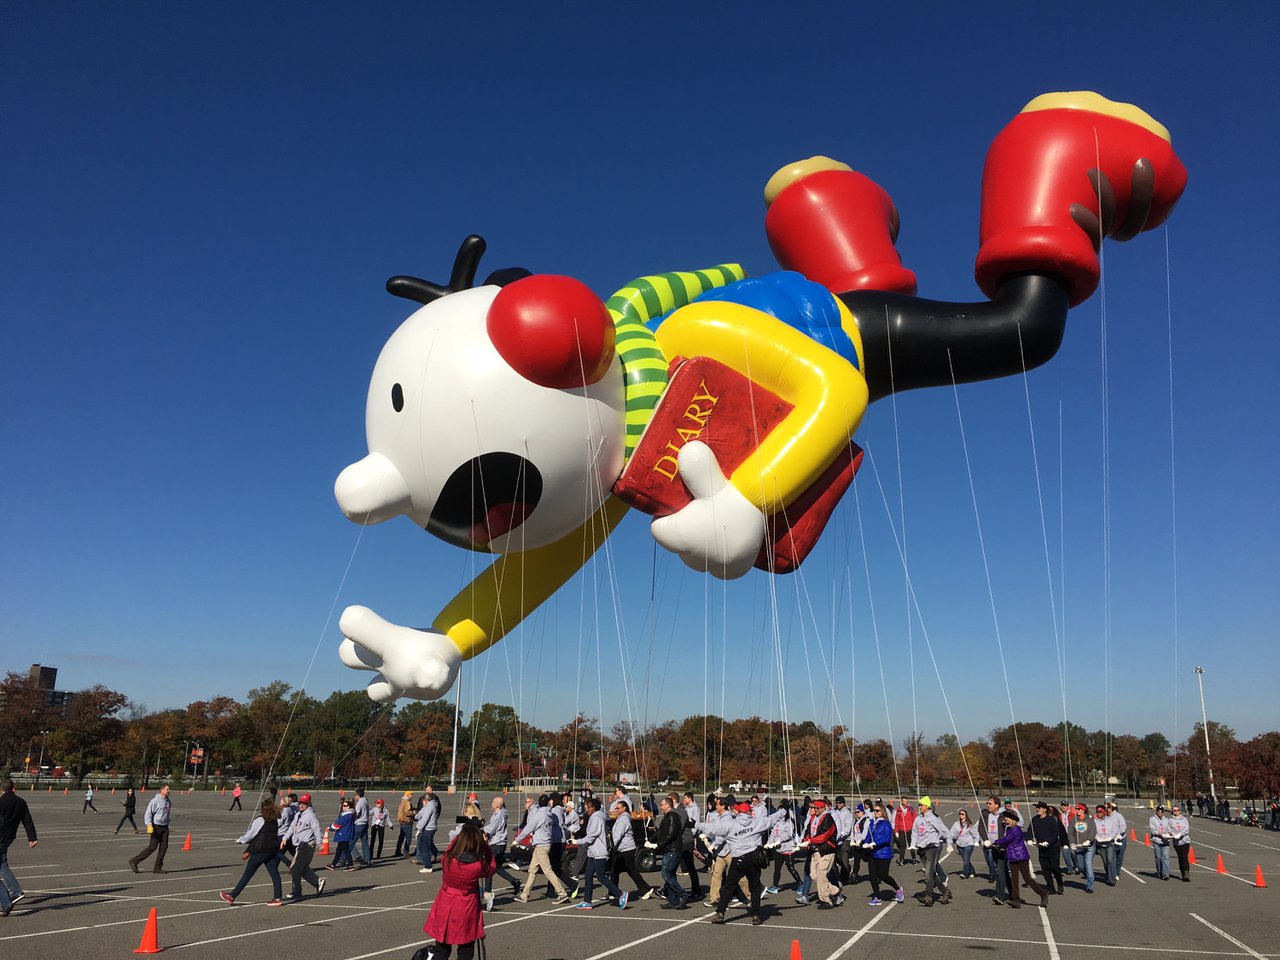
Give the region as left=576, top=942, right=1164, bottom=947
left=431, top=497, right=627, bottom=660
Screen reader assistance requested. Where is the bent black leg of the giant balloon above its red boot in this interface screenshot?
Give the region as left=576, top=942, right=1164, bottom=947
left=838, top=274, right=1068, bottom=401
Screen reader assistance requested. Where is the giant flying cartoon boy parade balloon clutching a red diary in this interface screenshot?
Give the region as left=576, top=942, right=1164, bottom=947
left=334, top=92, right=1187, bottom=700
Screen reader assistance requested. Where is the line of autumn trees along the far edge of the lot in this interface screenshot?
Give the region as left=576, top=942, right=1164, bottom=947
left=0, top=673, right=1280, bottom=797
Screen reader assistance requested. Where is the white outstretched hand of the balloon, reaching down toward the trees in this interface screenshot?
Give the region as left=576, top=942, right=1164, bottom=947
left=338, top=607, right=462, bottom=703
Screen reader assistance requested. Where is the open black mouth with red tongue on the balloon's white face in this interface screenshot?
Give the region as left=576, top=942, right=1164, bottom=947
left=426, top=453, right=543, bottom=550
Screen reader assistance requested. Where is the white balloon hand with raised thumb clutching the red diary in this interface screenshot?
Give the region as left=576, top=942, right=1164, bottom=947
left=649, top=440, right=765, bottom=580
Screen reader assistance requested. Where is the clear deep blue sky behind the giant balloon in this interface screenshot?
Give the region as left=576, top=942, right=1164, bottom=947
left=0, top=3, right=1280, bottom=740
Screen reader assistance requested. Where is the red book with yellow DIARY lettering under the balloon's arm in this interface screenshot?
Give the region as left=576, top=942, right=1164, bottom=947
left=613, top=357, right=861, bottom=573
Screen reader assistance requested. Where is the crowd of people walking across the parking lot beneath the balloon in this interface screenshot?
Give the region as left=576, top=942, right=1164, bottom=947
left=0, top=781, right=1228, bottom=960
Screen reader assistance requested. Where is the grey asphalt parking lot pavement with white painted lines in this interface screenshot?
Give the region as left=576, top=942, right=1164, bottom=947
left=0, top=791, right=1280, bottom=960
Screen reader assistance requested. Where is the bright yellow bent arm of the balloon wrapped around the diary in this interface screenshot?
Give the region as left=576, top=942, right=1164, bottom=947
left=655, top=301, right=868, bottom=513
